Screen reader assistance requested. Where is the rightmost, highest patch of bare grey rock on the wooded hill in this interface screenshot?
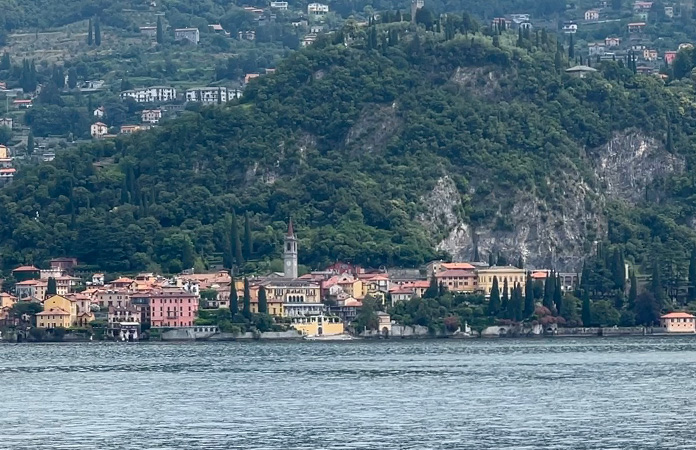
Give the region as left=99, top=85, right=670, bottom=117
left=591, top=130, right=684, bottom=204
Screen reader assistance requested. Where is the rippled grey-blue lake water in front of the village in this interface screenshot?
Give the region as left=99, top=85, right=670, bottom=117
left=0, top=336, right=696, bottom=450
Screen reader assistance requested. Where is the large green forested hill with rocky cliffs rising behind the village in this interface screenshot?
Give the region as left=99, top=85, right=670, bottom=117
left=0, top=20, right=696, bottom=278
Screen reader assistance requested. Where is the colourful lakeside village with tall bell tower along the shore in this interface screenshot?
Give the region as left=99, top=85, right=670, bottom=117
left=0, top=221, right=696, bottom=342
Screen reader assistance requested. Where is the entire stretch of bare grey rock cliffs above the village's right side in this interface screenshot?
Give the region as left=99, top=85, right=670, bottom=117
left=420, top=130, right=684, bottom=271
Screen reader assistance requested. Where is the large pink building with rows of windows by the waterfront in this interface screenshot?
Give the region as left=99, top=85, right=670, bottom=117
left=150, top=288, right=198, bottom=328
